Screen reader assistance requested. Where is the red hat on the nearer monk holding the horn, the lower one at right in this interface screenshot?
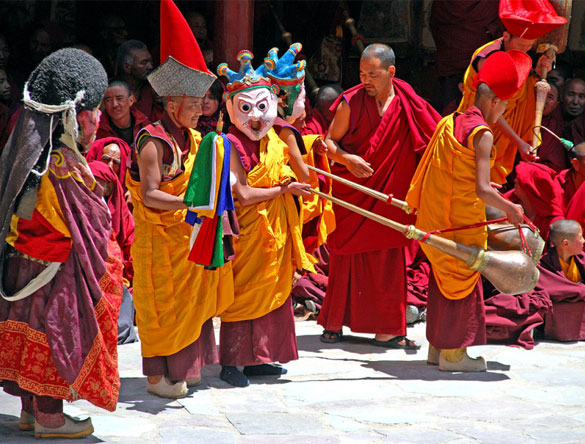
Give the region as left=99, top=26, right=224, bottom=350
left=473, top=49, right=532, bottom=100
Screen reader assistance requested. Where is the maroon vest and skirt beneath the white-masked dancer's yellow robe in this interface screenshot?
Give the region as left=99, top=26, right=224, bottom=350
left=219, top=125, right=299, bottom=366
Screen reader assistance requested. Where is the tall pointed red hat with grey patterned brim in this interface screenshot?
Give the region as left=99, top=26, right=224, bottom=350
left=148, top=0, right=216, bottom=97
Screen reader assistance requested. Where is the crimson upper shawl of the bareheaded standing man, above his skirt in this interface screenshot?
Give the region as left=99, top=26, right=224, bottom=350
left=328, top=78, right=440, bottom=254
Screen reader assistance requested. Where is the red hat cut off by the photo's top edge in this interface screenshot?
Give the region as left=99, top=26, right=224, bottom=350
left=500, top=0, right=567, bottom=40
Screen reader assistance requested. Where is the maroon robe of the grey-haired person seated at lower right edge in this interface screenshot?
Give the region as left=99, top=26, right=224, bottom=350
left=536, top=247, right=585, bottom=341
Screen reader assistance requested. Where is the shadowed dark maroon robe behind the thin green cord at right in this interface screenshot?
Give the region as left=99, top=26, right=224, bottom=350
left=538, top=106, right=571, bottom=173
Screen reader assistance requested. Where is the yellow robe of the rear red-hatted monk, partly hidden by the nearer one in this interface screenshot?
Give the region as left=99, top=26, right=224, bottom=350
left=457, top=38, right=537, bottom=184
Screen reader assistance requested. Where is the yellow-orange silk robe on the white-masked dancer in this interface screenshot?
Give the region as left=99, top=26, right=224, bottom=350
left=221, top=129, right=314, bottom=322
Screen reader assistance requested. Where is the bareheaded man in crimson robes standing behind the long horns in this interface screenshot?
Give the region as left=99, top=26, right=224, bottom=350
left=318, top=43, right=440, bottom=350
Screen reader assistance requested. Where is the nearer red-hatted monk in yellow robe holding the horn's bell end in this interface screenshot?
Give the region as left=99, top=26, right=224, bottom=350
left=406, top=50, right=531, bottom=371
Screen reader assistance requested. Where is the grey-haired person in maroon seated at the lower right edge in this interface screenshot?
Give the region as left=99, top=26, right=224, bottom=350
left=536, top=219, right=585, bottom=341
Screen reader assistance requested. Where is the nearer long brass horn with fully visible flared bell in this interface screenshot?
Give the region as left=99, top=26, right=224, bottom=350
left=309, top=188, right=539, bottom=294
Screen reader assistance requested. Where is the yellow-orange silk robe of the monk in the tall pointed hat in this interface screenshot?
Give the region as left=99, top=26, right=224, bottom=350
left=126, top=130, right=233, bottom=357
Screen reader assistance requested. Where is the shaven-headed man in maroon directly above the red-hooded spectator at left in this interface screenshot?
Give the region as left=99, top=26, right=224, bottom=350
left=96, top=80, right=151, bottom=146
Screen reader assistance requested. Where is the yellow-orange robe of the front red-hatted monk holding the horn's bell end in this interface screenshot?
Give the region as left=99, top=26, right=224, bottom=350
left=406, top=114, right=493, bottom=299
